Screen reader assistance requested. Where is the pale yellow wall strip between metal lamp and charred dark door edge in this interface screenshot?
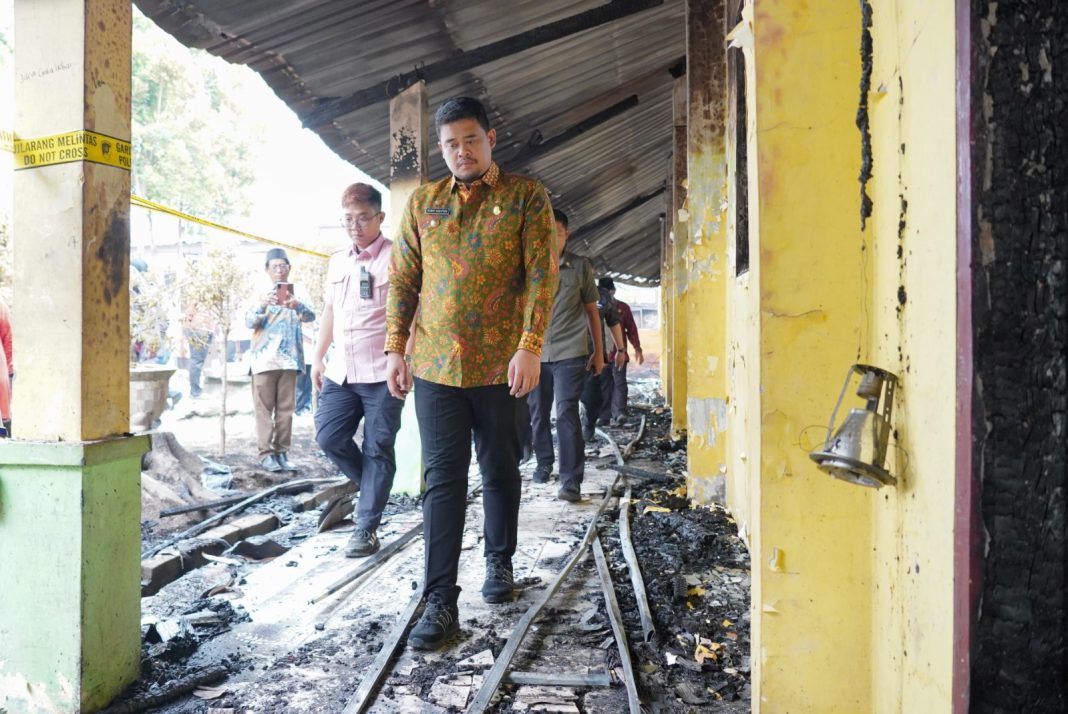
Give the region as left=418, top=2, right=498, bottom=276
left=868, top=2, right=956, bottom=712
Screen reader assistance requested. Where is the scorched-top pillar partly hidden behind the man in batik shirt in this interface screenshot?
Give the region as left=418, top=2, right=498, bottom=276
left=386, top=81, right=430, bottom=494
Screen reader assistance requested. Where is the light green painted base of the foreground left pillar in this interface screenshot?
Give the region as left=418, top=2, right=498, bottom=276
left=0, top=437, right=150, bottom=713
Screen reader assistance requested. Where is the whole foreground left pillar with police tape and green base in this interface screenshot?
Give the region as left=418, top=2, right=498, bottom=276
left=0, top=0, right=147, bottom=712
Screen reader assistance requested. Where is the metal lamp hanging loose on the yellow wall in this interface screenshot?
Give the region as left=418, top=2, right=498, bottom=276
left=808, top=364, right=897, bottom=489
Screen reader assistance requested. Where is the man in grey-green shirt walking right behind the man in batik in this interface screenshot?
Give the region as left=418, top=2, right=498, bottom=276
left=527, top=209, right=604, bottom=503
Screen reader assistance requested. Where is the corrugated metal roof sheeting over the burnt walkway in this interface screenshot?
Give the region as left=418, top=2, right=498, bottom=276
left=136, top=0, right=686, bottom=284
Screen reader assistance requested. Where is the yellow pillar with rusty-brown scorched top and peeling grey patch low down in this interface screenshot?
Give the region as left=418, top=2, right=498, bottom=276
left=686, top=0, right=728, bottom=503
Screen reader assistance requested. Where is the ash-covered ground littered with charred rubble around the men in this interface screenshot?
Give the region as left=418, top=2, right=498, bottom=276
left=111, top=360, right=750, bottom=714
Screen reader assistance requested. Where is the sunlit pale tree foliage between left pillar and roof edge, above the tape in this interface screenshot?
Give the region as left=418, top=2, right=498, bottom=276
left=131, top=13, right=255, bottom=231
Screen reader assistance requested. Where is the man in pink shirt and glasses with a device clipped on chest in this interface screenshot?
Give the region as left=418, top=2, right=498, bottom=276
left=312, top=184, right=404, bottom=558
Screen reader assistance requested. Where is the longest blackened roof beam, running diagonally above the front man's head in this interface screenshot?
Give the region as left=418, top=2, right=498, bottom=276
left=303, top=0, right=664, bottom=128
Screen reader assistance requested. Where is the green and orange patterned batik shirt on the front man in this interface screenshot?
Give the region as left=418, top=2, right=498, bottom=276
left=386, top=163, right=559, bottom=387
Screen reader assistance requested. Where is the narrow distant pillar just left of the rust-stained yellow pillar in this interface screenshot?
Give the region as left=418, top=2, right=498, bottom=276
left=670, top=76, right=689, bottom=433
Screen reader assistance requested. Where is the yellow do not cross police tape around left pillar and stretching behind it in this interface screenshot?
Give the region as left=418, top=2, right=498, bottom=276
left=0, top=130, right=330, bottom=258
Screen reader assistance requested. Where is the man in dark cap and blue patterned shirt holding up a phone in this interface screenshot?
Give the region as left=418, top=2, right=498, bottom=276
left=245, top=248, right=315, bottom=472
